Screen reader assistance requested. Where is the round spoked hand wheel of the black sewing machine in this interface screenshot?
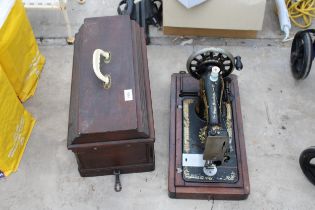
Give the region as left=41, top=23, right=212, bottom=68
left=186, top=48, right=235, bottom=79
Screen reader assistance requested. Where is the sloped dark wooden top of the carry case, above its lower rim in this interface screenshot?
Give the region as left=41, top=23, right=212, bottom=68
left=68, top=16, right=154, bottom=146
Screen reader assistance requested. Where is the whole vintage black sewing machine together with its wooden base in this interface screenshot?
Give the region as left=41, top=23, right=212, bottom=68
left=169, top=48, right=249, bottom=199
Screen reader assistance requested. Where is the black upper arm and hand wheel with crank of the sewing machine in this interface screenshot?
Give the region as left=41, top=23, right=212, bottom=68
left=187, top=48, right=243, bottom=141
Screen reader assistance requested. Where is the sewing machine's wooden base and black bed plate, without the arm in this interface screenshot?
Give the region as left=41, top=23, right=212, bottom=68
left=168, top=73, right=250, bottom=200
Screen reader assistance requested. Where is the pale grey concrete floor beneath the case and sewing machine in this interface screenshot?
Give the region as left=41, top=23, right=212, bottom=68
left=0, top=0, right=315, bottom=210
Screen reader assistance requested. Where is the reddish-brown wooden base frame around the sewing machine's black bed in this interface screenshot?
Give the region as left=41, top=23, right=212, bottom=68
left=168, top=73, right=250, bottom=200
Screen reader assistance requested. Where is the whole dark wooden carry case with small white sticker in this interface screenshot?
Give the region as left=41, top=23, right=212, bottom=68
left=68, top=16, right=155, bottom=176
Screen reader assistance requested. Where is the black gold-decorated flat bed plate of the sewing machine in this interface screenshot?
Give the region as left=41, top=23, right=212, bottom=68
left=182, top=99, right=239, bottom=184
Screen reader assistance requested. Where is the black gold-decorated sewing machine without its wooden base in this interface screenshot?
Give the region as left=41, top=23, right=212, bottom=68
left=180, top=48, right=243, bottom=180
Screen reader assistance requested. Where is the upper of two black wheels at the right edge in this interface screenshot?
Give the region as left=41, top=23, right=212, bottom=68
left=290, top=32, right=313, bottom=80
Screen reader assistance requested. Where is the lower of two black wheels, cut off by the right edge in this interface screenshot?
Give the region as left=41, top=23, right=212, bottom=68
left=300, top=147, right=315, bottom=185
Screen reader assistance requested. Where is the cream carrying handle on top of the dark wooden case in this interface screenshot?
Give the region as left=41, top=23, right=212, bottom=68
left=93, top=49, right=112, bottom=89
